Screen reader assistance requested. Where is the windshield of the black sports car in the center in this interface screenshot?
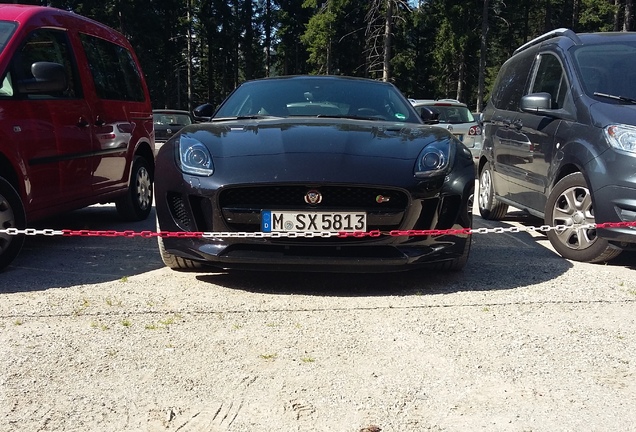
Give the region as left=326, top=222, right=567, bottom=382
left=214, top=76, right=421, bottom=123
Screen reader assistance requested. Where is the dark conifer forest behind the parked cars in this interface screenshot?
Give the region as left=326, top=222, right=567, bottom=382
left=0, top=0, right=634, bottom=111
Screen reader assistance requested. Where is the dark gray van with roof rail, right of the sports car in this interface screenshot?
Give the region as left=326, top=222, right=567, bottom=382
left=478, top=29, right=636, bottom=262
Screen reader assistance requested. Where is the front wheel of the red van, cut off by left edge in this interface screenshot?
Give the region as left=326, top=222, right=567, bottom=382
left=0, top=177, right=26, bottom=270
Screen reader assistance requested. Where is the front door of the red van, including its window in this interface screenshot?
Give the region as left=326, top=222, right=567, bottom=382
left=2, top=28, right=93, bottom=217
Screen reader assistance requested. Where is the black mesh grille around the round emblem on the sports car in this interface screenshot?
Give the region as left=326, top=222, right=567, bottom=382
left=219, top=185, right=409, bottom=232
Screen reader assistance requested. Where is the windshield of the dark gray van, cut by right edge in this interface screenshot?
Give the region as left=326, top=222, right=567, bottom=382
left=573, top=41, right=636, bottom=101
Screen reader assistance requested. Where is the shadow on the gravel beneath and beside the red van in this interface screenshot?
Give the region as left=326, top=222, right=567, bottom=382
left=0, top=205, right=164, bottom=293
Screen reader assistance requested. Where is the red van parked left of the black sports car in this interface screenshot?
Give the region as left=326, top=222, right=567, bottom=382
left=0, top=5, right=154, bottom=269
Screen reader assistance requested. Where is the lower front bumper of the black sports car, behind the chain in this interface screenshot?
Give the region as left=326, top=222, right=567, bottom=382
left=155, top=181, right=474, bottom=272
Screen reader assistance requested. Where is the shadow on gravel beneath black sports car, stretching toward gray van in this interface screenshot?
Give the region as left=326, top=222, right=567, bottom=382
left=197, top=212, right=572, bottom=297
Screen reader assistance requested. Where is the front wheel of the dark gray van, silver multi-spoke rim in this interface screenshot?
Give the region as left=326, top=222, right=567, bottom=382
left=545, top=173, right=622, bottom=263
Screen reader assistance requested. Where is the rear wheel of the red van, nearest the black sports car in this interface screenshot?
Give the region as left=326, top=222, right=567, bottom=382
left=115, top=156, right=153, bottom=222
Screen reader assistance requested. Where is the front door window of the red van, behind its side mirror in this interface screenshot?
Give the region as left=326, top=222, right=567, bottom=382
left=5, top=29, right=82, bottom=99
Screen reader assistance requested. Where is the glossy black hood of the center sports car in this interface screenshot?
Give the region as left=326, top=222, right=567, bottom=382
left=161, top=118, right=455, bottom=184
